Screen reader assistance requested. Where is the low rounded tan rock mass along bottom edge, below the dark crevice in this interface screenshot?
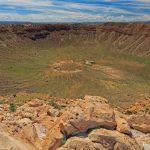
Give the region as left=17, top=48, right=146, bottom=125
left=58, top=129, right=141, bottom=150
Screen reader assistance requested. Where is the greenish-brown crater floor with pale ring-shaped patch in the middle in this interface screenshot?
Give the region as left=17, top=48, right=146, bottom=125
left=0, top=40, right=150, bottom=106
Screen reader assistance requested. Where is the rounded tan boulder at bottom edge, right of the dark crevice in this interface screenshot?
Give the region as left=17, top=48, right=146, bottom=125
left=88, top=129, right=140, bottom=150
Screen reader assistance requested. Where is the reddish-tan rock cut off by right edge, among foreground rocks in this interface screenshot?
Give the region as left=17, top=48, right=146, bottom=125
left=128, top=115, right=150, bottom=133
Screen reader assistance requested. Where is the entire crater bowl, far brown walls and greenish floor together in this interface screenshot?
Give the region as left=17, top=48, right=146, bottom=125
left=0, top=23, right=150, bottom=105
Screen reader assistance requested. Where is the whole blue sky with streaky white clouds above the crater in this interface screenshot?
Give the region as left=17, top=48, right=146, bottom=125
left=0, top=0, right=150, bottom=22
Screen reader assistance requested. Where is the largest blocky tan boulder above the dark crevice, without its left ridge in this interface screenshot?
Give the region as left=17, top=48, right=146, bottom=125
left=61, top=96, right=116, bottom=135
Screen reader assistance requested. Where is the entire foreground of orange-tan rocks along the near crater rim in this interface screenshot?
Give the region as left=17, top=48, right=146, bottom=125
left=0, top=96, right=150, bottom=150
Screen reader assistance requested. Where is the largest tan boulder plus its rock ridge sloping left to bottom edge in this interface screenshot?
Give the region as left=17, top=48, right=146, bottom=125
left=43, top=96, right=117, bottom=150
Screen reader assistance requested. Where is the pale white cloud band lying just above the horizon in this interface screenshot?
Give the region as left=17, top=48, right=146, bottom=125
left=0, top=11, right=150, bottom=22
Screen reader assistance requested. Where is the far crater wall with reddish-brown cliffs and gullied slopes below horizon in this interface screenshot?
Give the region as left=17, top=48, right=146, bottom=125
left=0, top=22, right=150, bottom=56
